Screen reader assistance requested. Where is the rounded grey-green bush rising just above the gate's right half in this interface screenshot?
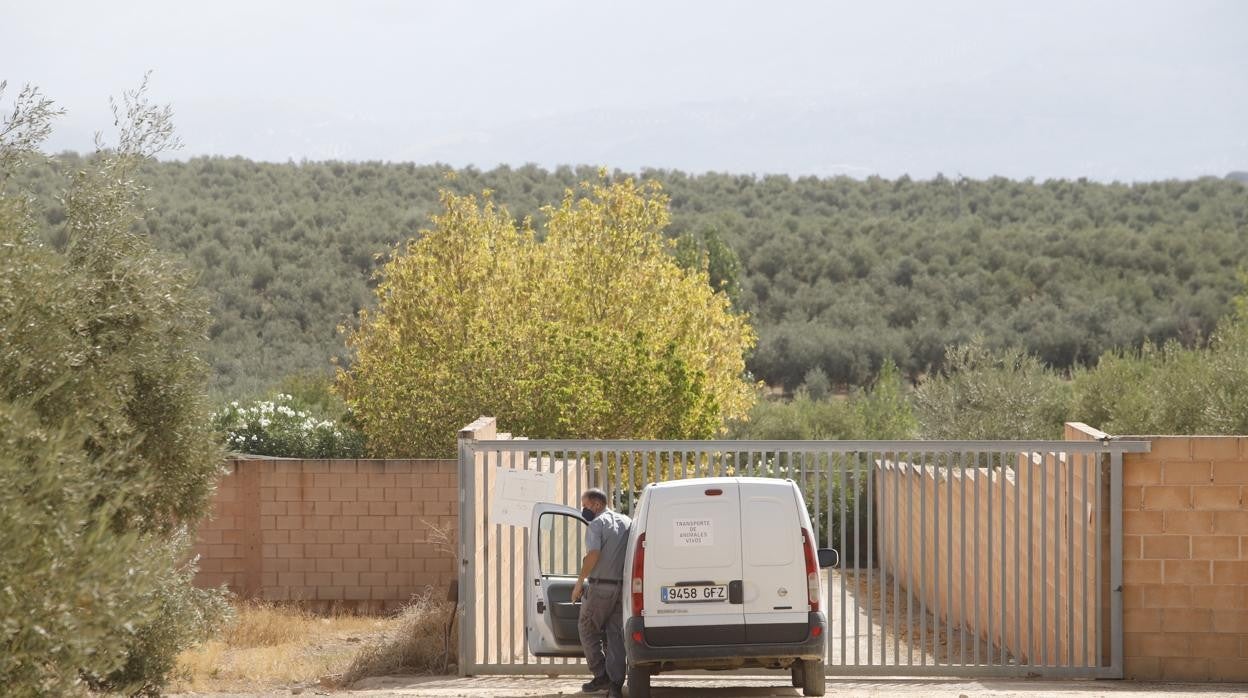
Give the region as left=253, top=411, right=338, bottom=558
left=915, top=340, right=1071, bottom=440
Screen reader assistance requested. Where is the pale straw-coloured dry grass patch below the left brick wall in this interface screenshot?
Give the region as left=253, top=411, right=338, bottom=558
left=170, top=603, right=399, bottom=691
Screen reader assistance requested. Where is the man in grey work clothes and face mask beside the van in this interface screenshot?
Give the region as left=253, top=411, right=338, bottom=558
left=572, top=487, right=633, bottom=698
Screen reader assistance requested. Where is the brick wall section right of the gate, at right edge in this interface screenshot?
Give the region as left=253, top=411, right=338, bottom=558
left=1122, top=436, right=1248, bottom=681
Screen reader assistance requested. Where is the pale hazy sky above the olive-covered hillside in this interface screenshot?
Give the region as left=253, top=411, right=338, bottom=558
left=0, top=0, right=1248, bottom=180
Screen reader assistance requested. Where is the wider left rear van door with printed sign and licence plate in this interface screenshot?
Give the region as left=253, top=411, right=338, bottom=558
left=644, top=478, right=745, bottom=646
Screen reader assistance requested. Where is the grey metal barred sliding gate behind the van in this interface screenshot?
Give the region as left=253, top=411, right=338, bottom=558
left=459, top=438, right=1148, bottom=678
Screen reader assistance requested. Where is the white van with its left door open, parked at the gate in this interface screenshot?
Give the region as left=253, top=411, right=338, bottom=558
left=525, top=477, right=837, bottom=698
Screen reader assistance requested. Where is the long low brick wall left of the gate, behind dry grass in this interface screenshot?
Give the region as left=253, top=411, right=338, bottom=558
left=195, top=458, right=458, bottom=611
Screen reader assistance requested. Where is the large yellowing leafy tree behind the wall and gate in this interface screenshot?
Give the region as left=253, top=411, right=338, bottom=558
left=338, top=180, right=755, bottom=457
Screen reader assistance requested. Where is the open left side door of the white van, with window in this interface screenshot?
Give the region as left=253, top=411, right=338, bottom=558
left=524, top=503, right=588, bottom=657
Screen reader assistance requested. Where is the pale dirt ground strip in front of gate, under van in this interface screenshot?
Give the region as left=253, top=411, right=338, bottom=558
left=173, top=674, right=1248, bottom=698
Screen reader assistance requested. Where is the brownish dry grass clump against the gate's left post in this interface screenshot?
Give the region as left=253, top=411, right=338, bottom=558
left=342, top=589, right=456, bottom=686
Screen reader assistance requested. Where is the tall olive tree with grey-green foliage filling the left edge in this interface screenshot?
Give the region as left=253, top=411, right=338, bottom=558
left=0, top=80, right=222, bottom=696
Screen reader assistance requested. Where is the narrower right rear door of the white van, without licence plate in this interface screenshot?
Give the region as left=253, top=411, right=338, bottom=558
left=740, top=478, right=810, bottom=643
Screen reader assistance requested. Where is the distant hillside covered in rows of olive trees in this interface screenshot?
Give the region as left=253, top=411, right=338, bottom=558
left=19, top=155, right=1248, bottom=397
